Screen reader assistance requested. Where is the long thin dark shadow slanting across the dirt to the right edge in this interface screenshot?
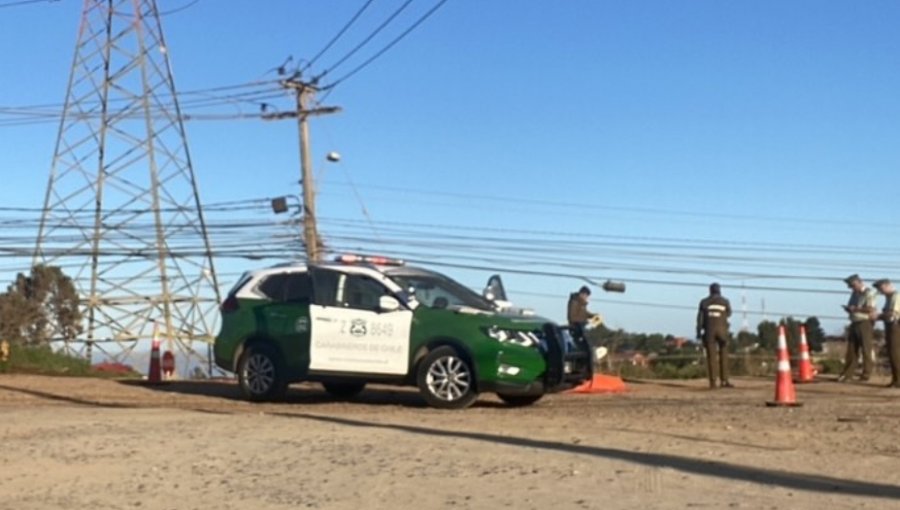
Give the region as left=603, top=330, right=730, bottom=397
left=272, top=413, right=900, bottom=500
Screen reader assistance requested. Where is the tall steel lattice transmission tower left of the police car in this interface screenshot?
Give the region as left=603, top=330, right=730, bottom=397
left=34, top=0, right=219, bottom=371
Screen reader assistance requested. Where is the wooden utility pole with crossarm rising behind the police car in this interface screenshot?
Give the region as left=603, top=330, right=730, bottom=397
left=263, top=76, right=341, bottom=262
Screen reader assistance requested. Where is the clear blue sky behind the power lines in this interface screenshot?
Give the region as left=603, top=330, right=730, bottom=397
left=0, top=0, right=900, bottom=336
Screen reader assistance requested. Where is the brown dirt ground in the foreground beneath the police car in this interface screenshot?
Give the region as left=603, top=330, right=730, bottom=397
left=0, top=375, right=900, bottom=510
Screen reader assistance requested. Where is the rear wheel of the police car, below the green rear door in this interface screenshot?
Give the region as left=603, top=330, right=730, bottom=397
left=238, top=344, right=287, bottom=402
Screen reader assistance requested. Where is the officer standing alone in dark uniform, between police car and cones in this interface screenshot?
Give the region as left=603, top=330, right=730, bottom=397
left=697, top=283, right=734, bottom=388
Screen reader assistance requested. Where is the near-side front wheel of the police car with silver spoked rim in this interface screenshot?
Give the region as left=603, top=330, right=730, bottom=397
left=416, top=346, right=478, bottom=409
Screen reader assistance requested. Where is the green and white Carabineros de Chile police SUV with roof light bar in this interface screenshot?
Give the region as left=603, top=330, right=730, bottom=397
left=214, top=255, right=592, bottom=409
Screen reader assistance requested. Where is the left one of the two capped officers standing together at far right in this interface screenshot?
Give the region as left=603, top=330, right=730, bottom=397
left=838, top=274, right=876, bottom=382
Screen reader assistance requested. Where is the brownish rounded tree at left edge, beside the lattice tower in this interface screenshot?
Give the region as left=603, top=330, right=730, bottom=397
left=0, top=265, right=82, bottom=345
